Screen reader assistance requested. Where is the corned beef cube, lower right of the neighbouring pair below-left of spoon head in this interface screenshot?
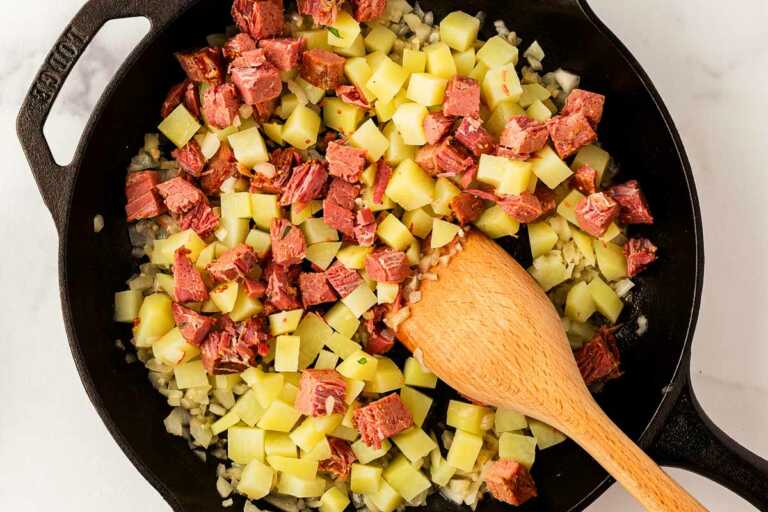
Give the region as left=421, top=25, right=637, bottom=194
left=352, top=393, right=413, bottom=450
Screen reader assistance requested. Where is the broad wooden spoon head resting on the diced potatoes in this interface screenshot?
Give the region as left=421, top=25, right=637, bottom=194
left=397, top=230, right=591, bottom=429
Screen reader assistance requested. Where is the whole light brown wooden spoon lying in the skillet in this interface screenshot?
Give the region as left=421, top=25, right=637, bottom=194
left=397, top=231, right=706, bottom=512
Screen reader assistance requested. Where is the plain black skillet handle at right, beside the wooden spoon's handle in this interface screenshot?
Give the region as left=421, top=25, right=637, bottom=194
left=649, top=368, right=768, bottom=511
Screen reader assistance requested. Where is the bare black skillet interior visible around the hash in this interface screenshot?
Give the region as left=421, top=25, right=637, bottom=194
left=61, top=0, right=697, bottom=511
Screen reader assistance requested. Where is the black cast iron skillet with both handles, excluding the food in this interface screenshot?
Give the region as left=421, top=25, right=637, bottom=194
left=18, top=0, right=768, bottom=511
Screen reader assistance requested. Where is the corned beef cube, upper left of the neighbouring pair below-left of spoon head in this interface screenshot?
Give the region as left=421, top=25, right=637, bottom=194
left=294, top=368, right=347, bottom=416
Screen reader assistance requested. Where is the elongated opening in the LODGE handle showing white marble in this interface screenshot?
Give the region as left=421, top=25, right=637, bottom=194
left=43, top=17, right=150, bottom=166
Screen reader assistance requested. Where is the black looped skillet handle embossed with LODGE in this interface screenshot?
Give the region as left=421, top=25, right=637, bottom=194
left=16, top=0, right=193, bottom=229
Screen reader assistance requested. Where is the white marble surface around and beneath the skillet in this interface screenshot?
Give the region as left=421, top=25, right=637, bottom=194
left=0, top=0, right=768, bottom=512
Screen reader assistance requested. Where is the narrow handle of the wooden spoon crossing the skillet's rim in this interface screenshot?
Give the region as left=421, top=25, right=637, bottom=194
left=566, top=400, right=707, bottom=512
